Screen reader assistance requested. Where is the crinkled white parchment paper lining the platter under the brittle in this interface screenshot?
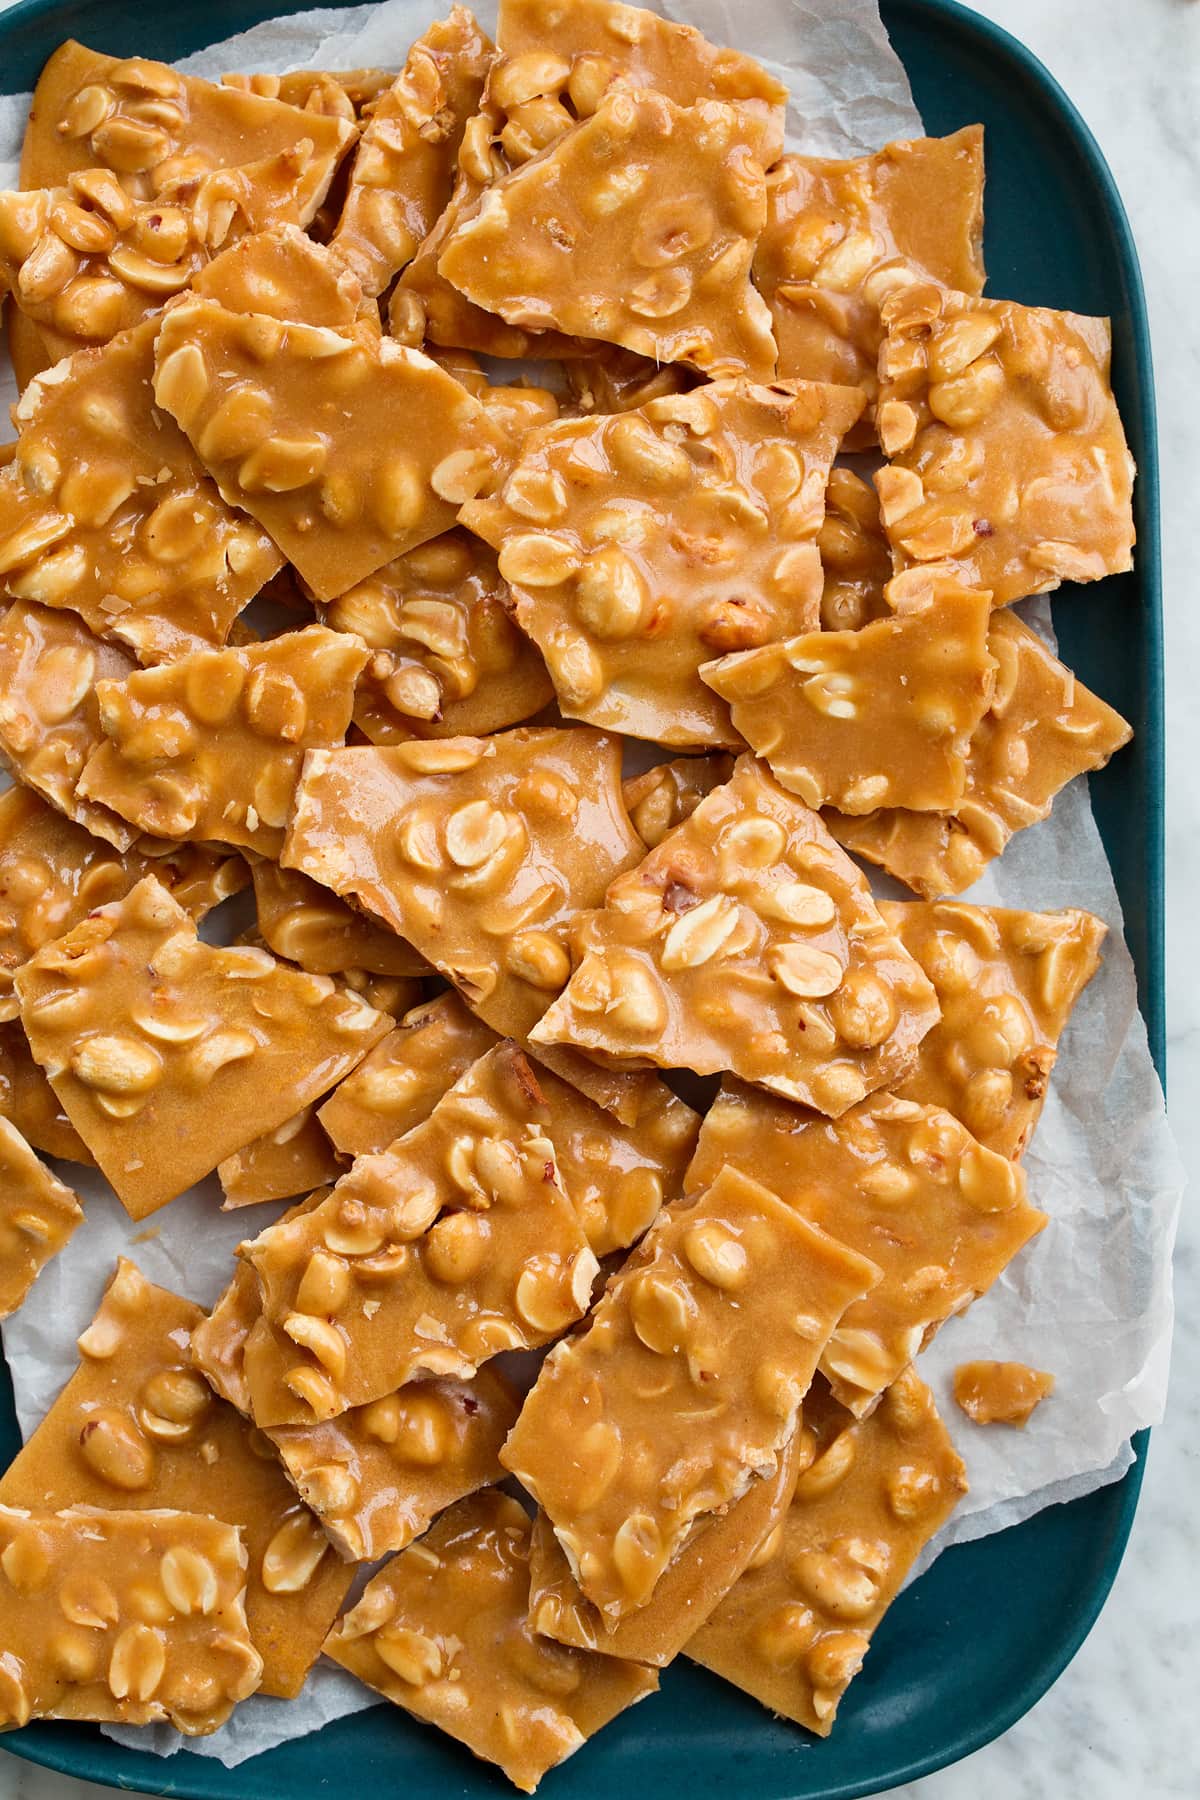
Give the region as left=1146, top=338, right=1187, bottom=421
left=0, top=0, right=1184, bottom=1766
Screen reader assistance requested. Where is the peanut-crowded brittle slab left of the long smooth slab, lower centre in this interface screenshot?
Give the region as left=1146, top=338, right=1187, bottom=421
left=243, top=1044, right=597, bottom=1426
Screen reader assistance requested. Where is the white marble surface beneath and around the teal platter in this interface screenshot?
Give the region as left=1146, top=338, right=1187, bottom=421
left=0, top=0, right=1200, bottom=1800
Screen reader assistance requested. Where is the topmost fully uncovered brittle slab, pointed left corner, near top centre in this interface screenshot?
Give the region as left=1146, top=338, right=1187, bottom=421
left=437, top=92, right=775, bottom=380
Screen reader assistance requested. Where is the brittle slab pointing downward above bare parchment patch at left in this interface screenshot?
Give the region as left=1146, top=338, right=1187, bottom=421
left=16, top=877, right=389, bottom=1219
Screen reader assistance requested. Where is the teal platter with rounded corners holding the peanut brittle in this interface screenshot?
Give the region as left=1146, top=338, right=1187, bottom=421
left=0, top=0, right=1166, bottom=1800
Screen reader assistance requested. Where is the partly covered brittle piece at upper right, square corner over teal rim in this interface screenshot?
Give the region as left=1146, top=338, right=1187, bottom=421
left=754, top=124, right=984, bottom=441
